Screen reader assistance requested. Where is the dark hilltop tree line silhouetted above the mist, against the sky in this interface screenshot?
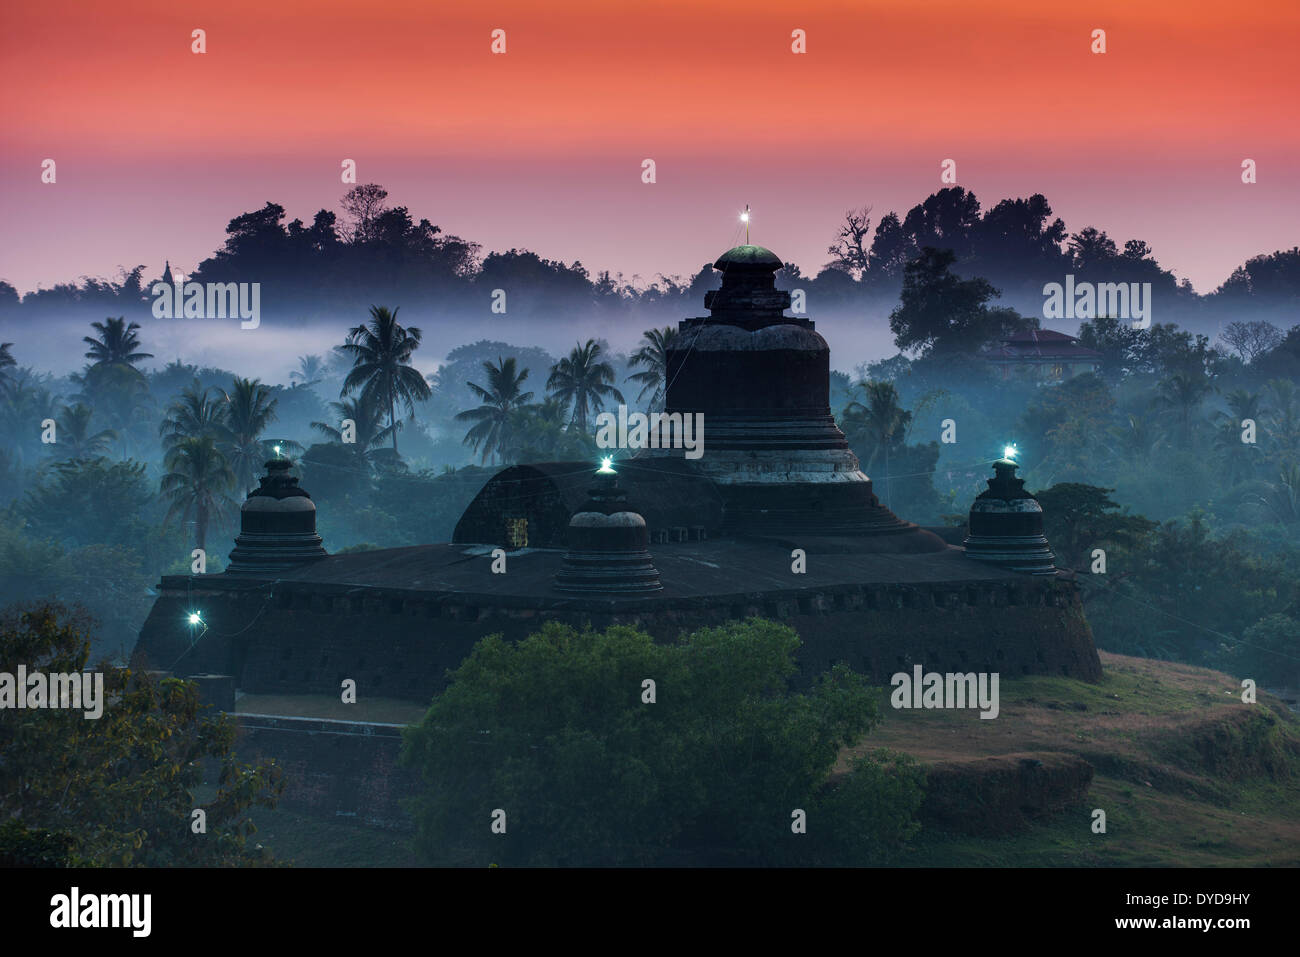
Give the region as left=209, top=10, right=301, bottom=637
left=0, top=183, right=1300, bottom=325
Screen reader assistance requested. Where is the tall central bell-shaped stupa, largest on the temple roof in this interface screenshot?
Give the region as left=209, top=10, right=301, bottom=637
left=634, top=244, right=945, bottom=551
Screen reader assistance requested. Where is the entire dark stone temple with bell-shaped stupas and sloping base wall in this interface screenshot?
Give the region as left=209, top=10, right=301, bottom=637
left=134, top=244, right=1101, bottom=702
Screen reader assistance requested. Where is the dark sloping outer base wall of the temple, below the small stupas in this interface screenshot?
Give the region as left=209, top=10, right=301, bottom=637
left=133, top=577, right=1101, bottom=703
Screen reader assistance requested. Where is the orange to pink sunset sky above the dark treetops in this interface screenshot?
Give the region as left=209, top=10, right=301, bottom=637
left=0, top=0, right=1300, bottom=291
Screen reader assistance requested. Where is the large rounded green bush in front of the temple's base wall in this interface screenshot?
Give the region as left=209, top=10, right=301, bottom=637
left=403, top=619, right=920, bottom=865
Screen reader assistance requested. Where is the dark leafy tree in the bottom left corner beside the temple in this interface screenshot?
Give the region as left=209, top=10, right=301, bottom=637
left=0, top=605, right=283, bottom=867
